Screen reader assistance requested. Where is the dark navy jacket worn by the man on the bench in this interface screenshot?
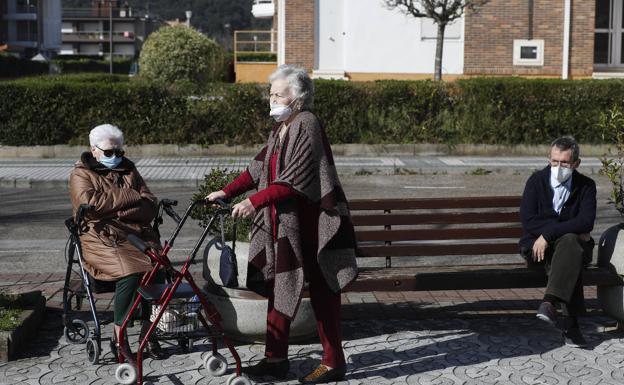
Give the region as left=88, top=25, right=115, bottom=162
left=520, top=166, right=596, bottom=249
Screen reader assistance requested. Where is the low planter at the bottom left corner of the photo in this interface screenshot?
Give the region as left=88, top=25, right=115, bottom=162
left=0, top=290, right=46, bottom=362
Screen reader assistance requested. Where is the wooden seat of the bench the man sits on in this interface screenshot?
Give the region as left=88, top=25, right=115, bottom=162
left=345, top=264, right=624, bottom=292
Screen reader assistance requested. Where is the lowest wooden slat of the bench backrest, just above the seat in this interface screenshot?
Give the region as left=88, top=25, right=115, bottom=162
left=358, top=242, right=519, bottom=258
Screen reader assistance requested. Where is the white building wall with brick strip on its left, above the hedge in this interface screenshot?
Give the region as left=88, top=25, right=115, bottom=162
left=286, top=0, right=463, bottom=77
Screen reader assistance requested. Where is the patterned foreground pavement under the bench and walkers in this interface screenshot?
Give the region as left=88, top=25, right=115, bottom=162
left=0, top=274, right=624, bottom=385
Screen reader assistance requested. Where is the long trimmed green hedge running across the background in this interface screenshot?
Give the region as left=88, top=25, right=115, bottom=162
left=0, top=75, right=624, bottom=145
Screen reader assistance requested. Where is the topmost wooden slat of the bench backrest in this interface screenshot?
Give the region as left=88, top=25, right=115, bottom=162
left=349, top=196, right=522, bottom=211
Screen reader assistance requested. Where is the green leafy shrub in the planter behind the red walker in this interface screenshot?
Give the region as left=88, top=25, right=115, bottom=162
left=191, top=168, right=252, bottom=242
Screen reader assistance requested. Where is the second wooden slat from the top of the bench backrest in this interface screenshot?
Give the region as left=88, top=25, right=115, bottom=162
left=351, top=212, right=520, bottom=226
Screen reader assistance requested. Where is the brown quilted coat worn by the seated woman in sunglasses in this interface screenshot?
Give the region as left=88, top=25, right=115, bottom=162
left=69, top=152, right=159, bottom=281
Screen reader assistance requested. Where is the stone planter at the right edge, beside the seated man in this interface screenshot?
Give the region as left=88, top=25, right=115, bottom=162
left=597, top=223, right=624, bottom=323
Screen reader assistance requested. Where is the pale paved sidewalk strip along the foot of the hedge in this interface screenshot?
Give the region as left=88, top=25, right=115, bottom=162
left=0, top=156, right=600, bottom=187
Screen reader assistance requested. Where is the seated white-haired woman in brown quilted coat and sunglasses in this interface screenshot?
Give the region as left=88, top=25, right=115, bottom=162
left=69, top=124, right=162, bottom=357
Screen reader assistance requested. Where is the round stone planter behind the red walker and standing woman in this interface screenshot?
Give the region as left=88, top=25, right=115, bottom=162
left=206, top=242, right=316, bottom=342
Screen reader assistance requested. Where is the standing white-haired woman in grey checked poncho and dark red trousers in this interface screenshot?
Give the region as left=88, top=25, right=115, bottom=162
left=207, top=65, right=357, bottom=384
